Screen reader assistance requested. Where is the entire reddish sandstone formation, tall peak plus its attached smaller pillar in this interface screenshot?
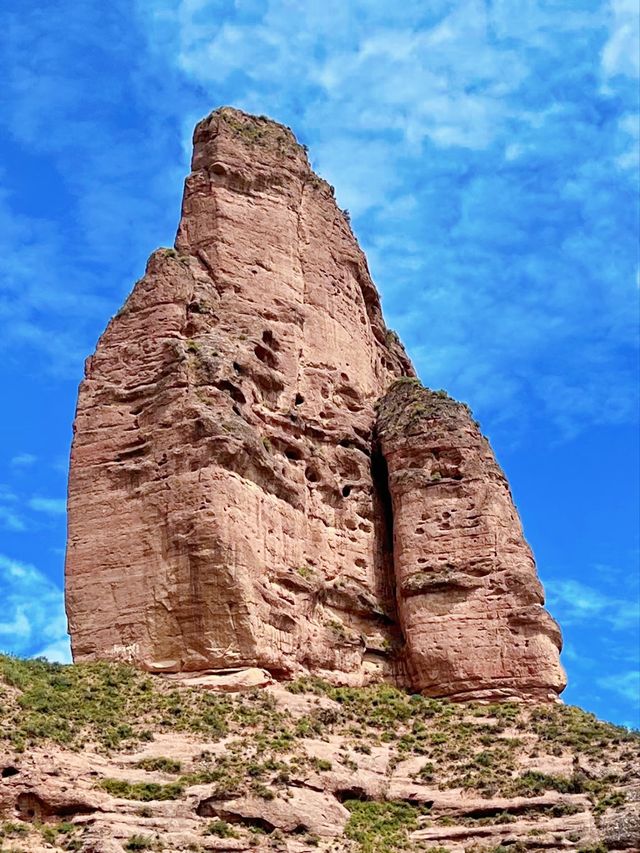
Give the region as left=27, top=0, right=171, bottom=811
left=66, top=108, right=563, bottom=698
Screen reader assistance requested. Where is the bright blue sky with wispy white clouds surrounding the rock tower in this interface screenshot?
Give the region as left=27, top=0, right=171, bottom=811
left=0, top=0, right=640, bottom=725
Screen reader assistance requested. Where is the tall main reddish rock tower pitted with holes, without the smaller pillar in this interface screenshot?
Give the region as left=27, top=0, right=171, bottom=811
left=66, top=109, right=413, bottom=682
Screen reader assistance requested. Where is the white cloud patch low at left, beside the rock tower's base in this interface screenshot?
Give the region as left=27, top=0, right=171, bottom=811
left=0, top=555, right=68, bottom=660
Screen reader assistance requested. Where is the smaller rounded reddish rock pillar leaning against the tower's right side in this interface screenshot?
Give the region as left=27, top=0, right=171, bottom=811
left=378, top=379, right=566, bottom=700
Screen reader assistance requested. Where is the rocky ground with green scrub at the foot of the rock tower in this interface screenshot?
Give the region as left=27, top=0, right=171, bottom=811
left=0, top=657, right=640, bottom=853
